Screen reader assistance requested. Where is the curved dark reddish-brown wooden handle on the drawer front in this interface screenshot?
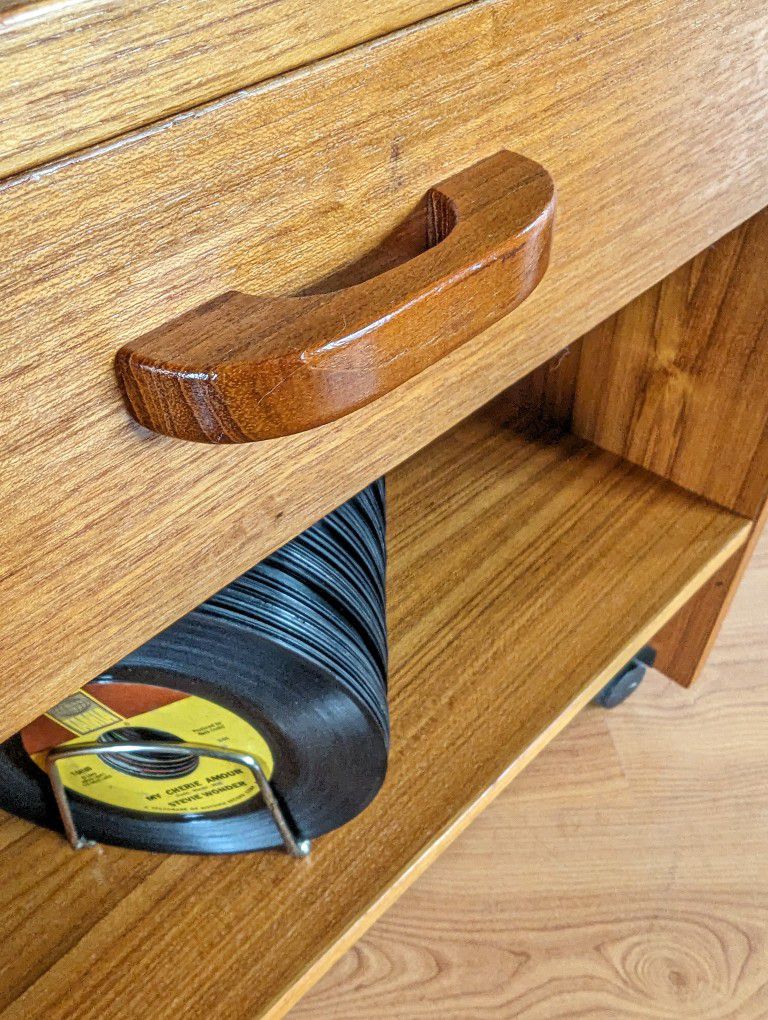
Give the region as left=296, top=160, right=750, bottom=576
left=115, top=152, right=555, bottom=443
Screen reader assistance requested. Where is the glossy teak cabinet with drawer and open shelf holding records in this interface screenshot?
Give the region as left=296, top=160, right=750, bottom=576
left=0, top=0, right=768, bottom=1020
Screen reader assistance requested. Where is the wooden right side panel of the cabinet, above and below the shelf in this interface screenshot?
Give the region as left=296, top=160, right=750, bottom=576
left=522, top=210, right=768, bottom=683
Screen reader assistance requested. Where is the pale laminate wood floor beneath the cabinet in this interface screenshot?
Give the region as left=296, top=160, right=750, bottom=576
left=291, top=534, right=768, bottom=1020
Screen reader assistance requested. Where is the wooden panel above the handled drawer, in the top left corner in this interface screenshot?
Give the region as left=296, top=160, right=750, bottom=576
left=0, top=0, right=459, bottom=175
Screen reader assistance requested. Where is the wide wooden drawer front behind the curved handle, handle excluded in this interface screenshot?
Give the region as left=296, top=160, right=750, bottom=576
left=0, top=0, right=768, bottom=732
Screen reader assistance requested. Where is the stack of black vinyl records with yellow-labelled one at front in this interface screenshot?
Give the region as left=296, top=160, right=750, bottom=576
left=0, top=480, right=389, bottom=853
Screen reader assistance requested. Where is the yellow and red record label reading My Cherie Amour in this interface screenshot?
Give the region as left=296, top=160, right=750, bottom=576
left=21, top=681, right=274, bottom=815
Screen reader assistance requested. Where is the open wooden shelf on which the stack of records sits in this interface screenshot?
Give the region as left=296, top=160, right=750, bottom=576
left=0, top=405, right=747, bottom=1020
